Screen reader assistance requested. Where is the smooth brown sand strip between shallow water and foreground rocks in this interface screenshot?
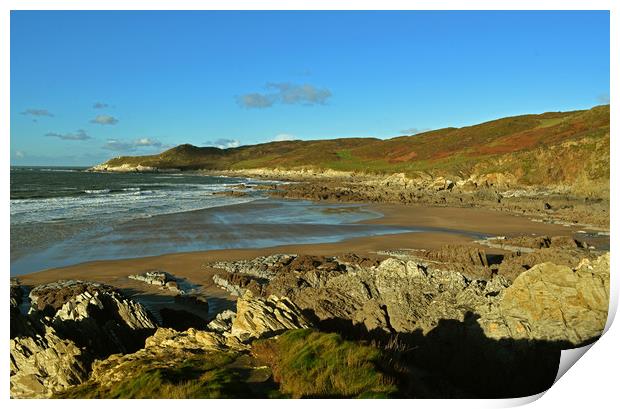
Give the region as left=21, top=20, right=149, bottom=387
left=19, top=205, right=577, bottom=288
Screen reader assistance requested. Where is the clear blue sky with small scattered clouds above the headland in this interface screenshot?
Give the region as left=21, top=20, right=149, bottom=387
left=10, top=11, right=610, bottom=166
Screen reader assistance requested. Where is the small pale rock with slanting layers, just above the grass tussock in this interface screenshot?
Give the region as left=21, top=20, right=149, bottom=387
left=231, top=291, right=311, bottom=340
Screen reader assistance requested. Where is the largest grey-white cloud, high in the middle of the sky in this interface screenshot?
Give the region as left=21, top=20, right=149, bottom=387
left=237, top=82, right=332, bottom=109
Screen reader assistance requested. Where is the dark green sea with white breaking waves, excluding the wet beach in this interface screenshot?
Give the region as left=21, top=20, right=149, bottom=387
left=11, top=167, right=265, bottom=224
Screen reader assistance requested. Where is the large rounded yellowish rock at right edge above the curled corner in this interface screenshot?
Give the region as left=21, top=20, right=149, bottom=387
left=484, top=253, right=609, bottom=346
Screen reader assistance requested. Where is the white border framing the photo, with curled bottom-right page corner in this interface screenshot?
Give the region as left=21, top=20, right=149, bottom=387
left=0, top=0, right=620, bottom=408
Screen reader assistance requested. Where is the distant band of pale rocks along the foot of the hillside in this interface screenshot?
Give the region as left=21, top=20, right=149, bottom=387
left=271, top=174, right=609, bottom=229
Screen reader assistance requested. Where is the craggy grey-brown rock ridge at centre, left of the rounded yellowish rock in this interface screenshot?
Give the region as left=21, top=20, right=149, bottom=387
left=254, top=258, right=508, bottom=332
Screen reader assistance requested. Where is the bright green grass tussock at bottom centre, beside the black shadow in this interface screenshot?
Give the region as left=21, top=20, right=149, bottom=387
left=253, top=329, right=397, bottom=398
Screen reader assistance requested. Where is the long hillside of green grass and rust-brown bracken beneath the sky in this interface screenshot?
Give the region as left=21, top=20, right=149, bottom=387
left=107, top=105, right=609, bottom=193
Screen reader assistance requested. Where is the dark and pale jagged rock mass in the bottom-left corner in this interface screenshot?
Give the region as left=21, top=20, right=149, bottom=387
left=11, top=281, right=155, bottom=397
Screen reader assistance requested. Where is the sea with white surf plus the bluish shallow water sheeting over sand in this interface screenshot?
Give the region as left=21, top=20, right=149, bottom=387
left=10, top=167, right=411, bottom=275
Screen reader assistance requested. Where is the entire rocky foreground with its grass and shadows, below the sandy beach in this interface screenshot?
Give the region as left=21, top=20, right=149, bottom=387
left=11, top=234, right=610, bottom=398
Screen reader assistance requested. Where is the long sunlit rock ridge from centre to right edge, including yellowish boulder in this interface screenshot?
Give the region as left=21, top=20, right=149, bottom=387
left=213, top=251, right=609, bottom=346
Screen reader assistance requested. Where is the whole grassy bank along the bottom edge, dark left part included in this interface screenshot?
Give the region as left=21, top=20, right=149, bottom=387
left=55, top=330, right=398, bottom=399
